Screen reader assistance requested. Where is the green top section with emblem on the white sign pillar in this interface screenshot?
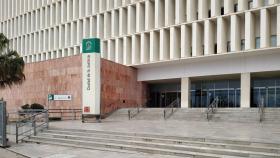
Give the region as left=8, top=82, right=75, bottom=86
left=82, top=38, right=100, bottom=53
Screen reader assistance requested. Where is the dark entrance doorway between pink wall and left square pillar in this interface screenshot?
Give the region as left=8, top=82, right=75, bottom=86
left=148, top=83, right=181, bottom=108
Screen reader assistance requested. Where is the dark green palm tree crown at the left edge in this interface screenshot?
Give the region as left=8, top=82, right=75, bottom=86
left=0, top=33, right=25, bottom=89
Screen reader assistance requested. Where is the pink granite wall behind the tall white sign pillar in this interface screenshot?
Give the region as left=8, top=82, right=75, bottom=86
left=0, top=55, right=147, bottom=117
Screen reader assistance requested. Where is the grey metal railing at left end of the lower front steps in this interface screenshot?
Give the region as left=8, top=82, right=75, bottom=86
left=16, top=110, right=49, bottom=144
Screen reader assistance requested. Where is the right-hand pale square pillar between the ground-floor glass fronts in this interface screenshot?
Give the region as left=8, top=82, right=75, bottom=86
left=240, top=72, right=251, bottom=108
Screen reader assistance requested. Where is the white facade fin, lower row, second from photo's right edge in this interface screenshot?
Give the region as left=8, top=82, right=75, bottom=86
left=260, top=9, right=271, bottom=48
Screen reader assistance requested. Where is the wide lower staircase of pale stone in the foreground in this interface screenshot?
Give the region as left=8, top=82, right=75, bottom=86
left=24, top=128, right=280, bottom=158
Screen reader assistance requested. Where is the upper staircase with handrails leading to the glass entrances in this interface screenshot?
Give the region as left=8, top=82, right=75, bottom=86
left=107, top=108, right=280, bottom=124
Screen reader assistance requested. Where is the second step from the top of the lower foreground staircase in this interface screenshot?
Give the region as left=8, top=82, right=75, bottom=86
left=40, top=133, right=280, bottom=154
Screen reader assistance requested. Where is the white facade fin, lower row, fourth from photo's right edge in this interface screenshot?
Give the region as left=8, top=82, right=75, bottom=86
left=230, top=15, right=241, bottom=52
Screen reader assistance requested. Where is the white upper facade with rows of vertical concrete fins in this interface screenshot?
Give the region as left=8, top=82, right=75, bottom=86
left=0, top=0, right=280, bottom=65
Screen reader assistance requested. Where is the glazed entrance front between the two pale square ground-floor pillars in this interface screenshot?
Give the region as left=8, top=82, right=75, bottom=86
left=191, top=80, right=240, bottom=108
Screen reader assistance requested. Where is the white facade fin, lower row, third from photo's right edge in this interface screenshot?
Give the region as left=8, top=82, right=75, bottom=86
left=245, top=12, right=255, bottom=50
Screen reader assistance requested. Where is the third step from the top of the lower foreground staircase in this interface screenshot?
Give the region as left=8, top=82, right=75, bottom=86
left=25, top=136, right=280, bottom=157
